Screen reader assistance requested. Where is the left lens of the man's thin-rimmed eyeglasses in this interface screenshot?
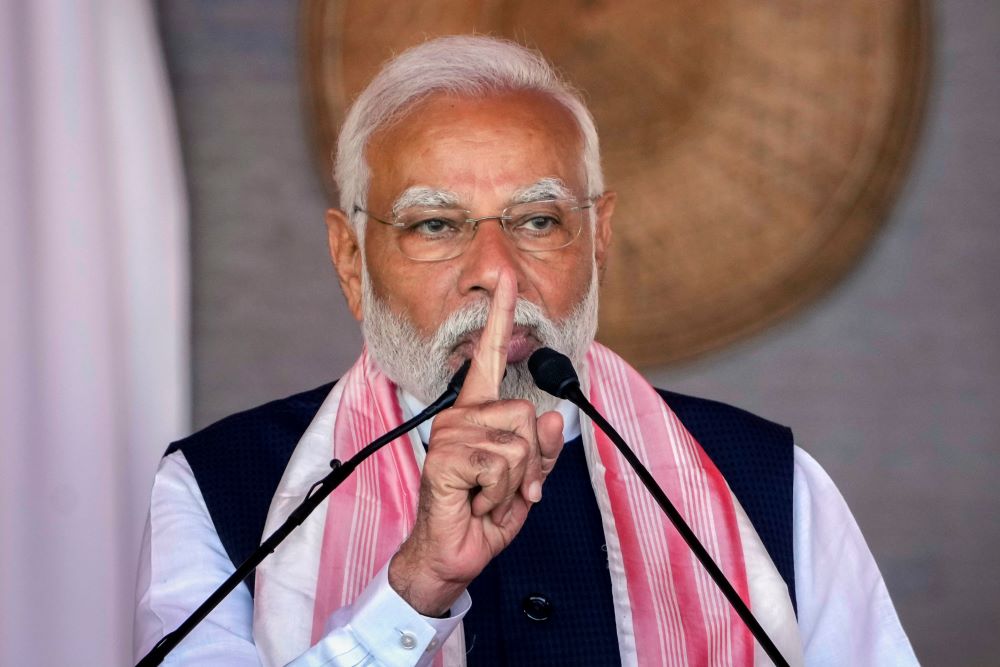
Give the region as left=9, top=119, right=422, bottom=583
left=396, top=208, right=472, bottom=262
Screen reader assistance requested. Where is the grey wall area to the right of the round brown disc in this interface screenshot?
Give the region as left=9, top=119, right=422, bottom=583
left=649, top=2, right=1000, bottom=665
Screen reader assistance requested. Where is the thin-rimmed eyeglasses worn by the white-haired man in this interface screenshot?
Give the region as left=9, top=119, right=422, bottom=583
left=354, top=199, right=594, bottom=262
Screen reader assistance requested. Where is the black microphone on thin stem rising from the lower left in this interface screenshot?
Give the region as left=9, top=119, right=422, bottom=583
left=136, top=360, right=471, bottom=667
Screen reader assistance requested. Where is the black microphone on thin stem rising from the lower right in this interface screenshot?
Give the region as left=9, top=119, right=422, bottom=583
left=528, top=347, right=788, bottom=667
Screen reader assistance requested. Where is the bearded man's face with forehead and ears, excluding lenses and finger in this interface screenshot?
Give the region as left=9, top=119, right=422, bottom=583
left=331, top=92, right=613, bottom=400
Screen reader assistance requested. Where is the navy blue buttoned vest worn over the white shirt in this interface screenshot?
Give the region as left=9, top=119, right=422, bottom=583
left=167, top=384, right=795, bottom=665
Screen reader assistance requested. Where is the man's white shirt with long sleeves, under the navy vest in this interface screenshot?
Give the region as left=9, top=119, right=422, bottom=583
left=134, top=400, right=917, bottom=667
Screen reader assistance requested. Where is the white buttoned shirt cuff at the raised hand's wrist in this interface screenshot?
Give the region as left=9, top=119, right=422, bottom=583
left=326, top=563, right=472, bottom=665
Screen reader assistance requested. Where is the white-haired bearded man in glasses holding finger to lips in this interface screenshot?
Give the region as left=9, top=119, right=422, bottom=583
left=136, top=37, right=915, bottom=665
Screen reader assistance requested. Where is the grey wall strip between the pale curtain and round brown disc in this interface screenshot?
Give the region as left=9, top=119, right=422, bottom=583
left=159, top=0, right=361, bottom=426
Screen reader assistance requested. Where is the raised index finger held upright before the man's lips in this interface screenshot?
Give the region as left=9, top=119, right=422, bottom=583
left=455, top=273, right=517, bottom=405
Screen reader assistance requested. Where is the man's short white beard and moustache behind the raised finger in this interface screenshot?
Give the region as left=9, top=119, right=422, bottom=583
left=361, top=266, right=598, bottom=414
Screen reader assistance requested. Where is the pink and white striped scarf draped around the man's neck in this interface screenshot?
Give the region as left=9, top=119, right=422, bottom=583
left=254, top=343, right=801, bottom=665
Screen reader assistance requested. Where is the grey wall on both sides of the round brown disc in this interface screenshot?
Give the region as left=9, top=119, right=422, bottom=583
left=160, top=0, right=1000, bottom=665
